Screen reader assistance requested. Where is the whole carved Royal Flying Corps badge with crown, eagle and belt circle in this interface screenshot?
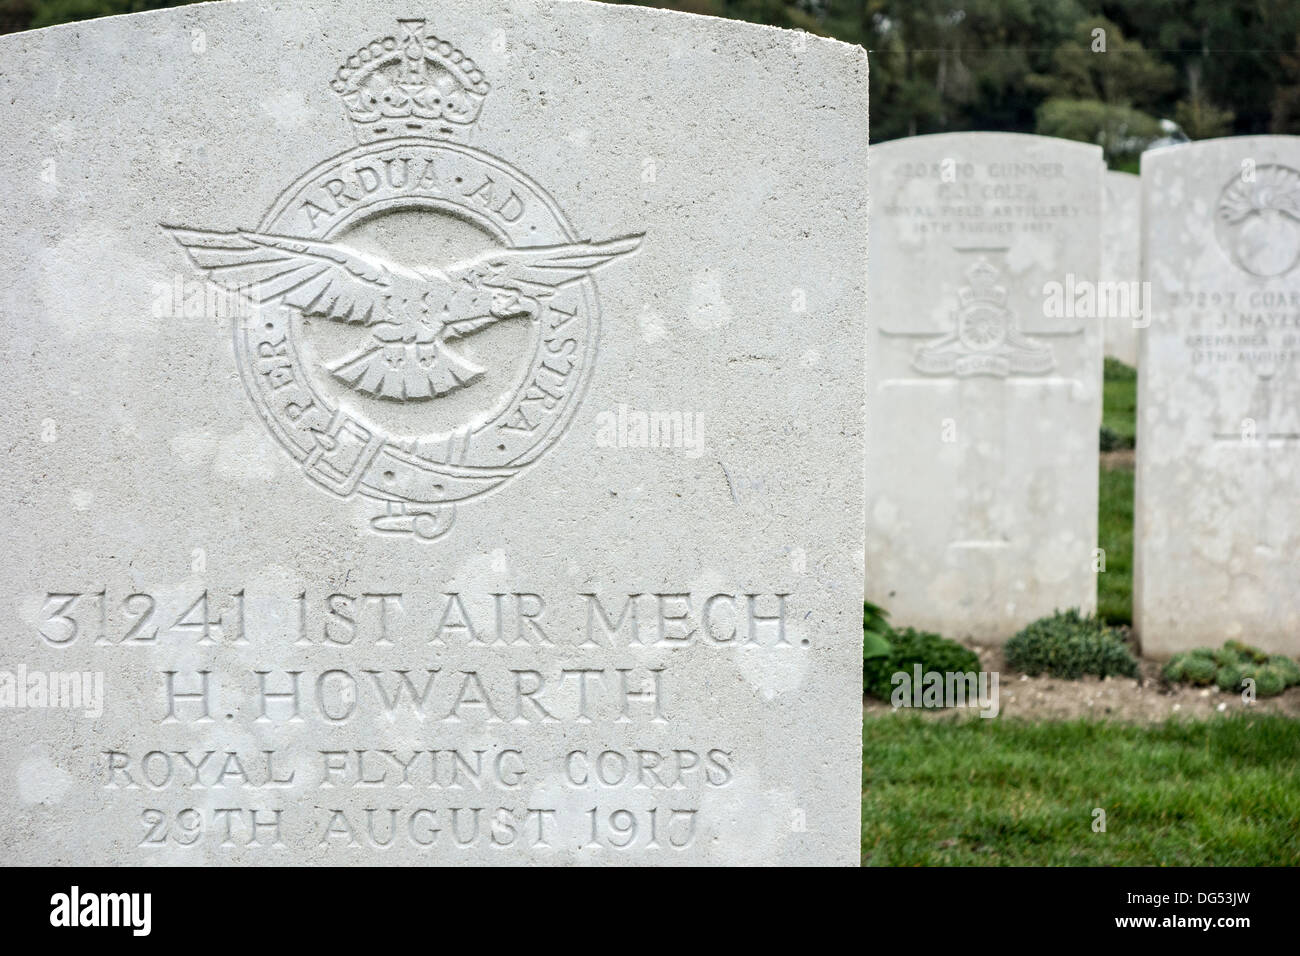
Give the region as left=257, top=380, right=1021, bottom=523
left=164, top=20, right=641, bottom=541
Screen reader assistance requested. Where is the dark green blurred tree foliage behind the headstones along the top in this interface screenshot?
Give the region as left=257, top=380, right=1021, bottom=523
left=10, top=0, right=1300, bottom=164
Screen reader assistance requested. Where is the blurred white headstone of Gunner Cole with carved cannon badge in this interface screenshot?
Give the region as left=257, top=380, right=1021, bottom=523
left=867, top=133, right=1102, bottom=643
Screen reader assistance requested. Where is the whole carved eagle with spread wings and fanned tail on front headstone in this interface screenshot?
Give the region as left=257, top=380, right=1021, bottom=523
left=164, top=226, right=641, bottom=402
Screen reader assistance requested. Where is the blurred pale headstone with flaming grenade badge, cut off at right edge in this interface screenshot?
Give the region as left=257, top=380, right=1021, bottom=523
left=1134, top=137, right=1300, bottom=656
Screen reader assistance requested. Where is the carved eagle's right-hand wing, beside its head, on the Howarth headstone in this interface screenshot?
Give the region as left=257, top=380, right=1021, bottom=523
left=441, top=235, right=642, bottom=338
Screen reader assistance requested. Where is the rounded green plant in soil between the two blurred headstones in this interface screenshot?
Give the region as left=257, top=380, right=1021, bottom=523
left=1005, top=607, right=1138, bottom=680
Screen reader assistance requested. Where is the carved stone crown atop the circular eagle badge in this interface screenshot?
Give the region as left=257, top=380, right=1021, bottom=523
left=330, top=20, right=491, bottom=143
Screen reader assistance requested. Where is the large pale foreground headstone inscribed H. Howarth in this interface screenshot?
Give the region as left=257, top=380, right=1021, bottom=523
left=0, top=0, right=867, bottom=864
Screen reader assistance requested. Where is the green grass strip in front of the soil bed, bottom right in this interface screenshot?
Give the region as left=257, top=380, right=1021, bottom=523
left=862, top=715, right=1300, bottom=866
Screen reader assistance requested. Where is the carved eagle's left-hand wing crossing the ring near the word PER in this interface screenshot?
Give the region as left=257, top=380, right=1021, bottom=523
left=164, top=226, right=421, bottom=325
